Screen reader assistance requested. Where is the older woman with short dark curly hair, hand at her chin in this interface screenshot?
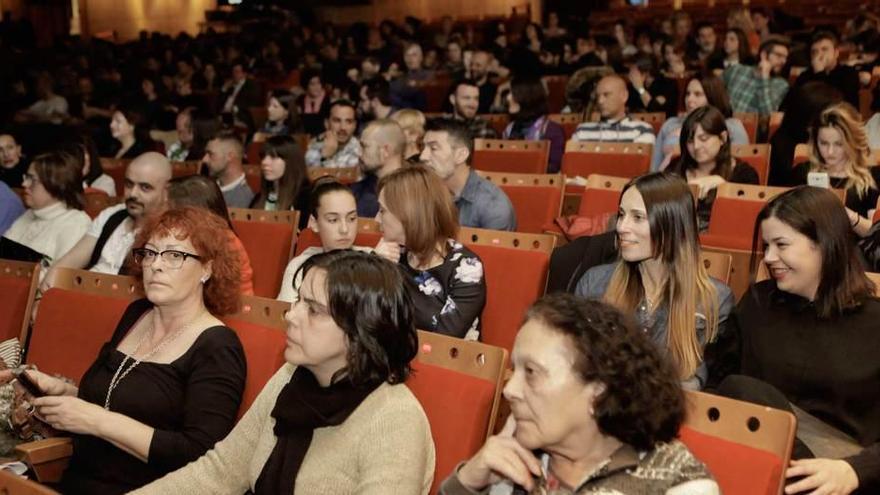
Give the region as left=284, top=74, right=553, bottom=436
left=440, top=293, right=719, bottom=495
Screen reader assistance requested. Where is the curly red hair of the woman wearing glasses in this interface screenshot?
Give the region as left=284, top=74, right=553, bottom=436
left=133, top=206, right=241, bottom=316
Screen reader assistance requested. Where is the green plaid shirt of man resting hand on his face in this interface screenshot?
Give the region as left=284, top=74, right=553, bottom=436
left=723, top=65, right=788, bottom=115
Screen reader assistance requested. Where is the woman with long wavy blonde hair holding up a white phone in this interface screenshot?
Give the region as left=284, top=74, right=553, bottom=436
left=791, top=103, right=880, bottom=236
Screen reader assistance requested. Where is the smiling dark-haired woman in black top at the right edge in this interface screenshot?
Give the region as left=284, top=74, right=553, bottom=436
left=712, top=186, right=880, bottom=494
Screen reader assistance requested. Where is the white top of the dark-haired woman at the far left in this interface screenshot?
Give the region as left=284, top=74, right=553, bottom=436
left=3, top=201, right=91, bottom=266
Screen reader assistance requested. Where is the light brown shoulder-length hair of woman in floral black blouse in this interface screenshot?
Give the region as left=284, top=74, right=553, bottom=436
left=377, top=165, right=458, bottom=263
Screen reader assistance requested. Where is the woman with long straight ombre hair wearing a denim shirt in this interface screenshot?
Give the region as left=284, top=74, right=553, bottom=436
left=575, top=173, right=734, bottom=389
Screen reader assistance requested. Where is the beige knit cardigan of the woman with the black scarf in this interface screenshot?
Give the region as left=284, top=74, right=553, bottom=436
left=132, top=364, right=434, bottom=495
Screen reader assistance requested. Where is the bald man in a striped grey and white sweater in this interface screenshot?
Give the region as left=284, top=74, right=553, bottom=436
left=571, top=74, right=654, bottom=144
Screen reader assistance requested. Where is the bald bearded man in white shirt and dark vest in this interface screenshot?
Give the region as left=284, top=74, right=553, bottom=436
left=40, top=151, right=171, bottom=284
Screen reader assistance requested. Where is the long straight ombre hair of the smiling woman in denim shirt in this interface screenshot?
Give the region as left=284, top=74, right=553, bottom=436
left=604, top=172, right=719, bottom=379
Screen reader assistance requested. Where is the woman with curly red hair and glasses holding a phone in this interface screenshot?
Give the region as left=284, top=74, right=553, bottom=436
left=27, top=207, right=247, bottom=494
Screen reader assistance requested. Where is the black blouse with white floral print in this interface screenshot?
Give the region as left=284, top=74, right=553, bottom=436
left=399, top=239, right=486, bottom=340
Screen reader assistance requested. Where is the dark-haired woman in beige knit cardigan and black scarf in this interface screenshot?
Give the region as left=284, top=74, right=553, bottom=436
left=135, top=250, right=434, bottom=495
